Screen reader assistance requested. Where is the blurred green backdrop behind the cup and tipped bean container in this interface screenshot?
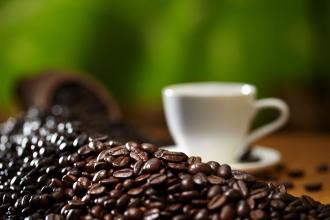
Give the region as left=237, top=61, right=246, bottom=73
left=0, top=0, right=330, bottom=131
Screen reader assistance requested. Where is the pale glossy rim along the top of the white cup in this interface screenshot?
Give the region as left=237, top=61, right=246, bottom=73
left=162, top=81, right=256, bottom=97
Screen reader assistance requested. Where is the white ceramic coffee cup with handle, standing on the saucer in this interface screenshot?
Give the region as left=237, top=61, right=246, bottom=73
left=162, top=82, right=289, bottom=163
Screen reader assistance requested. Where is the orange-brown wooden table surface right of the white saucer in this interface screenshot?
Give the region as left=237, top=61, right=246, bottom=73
left=257, top=133, right=330, bottom=204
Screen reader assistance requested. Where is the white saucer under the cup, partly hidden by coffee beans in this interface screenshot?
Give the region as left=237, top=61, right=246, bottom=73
left=163, top=145, right=281, bottom=173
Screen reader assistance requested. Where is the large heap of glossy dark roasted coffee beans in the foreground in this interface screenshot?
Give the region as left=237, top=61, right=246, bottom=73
left=0, top=109, right=330, bottom=220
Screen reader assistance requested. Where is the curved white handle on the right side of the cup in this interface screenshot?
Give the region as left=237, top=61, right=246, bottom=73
left=245, top=98, right=290, bottom=146
